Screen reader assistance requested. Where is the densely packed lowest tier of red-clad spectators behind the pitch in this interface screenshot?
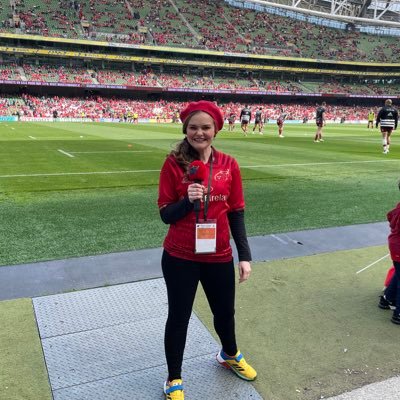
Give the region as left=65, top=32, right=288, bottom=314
left=0, top=94, right=377, bottom=122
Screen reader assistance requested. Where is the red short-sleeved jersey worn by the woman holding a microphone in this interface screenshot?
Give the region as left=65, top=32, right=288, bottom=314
left=158, top=149, right=245, bottom=262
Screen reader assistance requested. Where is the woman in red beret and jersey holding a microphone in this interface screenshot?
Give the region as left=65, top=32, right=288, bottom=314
left=158, top=101, right=257, bottom=400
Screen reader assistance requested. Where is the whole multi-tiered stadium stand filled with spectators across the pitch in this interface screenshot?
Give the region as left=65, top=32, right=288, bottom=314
left=0, top=0, right=400, bottom=120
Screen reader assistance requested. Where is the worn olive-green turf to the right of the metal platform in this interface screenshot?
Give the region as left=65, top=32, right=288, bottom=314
left=195, top=246, right=400, bottom=400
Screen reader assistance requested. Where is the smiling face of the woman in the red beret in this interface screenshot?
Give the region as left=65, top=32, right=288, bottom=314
left=186, top=111, right=215, bottom=153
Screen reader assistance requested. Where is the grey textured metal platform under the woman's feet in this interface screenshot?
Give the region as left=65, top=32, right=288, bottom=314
left=33, top=279, right=262, bottom=400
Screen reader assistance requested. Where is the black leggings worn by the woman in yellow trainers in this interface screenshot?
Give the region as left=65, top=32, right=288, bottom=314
left=161, top=250, right=237, bottom=380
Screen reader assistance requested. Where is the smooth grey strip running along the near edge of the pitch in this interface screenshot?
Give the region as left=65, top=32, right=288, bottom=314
left=0, top=222, right=389, bottom=300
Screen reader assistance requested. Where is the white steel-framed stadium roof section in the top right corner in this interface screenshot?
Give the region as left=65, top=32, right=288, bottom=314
left=247, top=0, right=400, bottom=27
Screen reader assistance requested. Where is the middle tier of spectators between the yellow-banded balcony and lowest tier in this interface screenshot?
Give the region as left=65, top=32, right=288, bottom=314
left=0, top=63, right=400, bottom=96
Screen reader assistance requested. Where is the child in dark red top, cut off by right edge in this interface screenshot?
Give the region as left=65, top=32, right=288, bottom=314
left=379, top=203, right=400, bottom=325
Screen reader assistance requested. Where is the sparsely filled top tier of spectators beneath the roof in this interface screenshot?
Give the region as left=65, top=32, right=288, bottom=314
left=1, top=0, right=400, bottom=62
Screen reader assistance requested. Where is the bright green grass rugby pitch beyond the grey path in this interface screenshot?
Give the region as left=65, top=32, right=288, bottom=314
left=0, top=123, right=400, bottom=265
